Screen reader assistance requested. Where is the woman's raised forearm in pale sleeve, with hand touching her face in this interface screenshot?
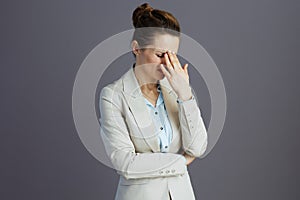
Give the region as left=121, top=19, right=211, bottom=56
left=160, top=51, right=207, bottom=157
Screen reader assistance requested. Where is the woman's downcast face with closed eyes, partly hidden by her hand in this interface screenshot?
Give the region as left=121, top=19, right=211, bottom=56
left=136, top=34, right=179, bottom=82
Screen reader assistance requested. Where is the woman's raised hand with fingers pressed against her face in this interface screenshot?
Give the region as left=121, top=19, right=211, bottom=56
left=160, top=51, right=192, bottom=101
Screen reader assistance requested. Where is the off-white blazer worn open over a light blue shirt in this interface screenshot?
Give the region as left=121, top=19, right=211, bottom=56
left=99, top=67, right=207, bottom=200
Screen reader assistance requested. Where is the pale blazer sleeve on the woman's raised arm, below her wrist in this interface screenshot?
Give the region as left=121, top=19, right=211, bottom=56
left=177, top=95, right=207, bottom=157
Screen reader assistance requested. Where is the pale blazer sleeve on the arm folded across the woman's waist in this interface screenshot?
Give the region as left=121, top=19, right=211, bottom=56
left=99, top=86, right=187, bottom=179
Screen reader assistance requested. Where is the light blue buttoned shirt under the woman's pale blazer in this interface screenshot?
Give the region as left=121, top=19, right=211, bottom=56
left=145, top=85, right=173, bottom=152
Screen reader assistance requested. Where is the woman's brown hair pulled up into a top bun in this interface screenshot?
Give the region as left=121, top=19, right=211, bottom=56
left=132, top=3, right=180, bottom=53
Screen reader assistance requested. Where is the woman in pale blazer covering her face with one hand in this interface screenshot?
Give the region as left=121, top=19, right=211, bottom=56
left=100, top=3, right=207, bottom=200
